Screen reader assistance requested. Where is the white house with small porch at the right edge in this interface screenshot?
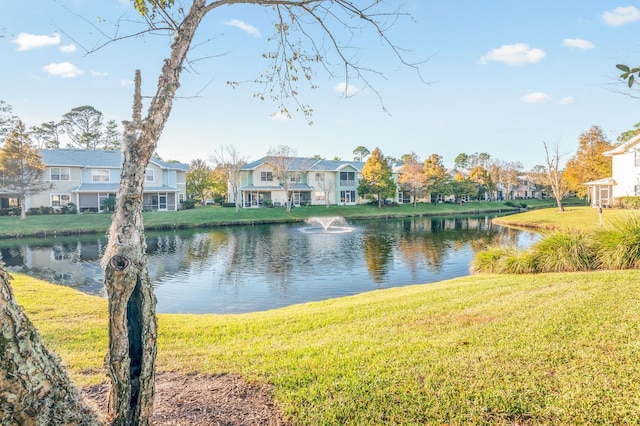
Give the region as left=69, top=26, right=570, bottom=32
left=585, top=135, right=640, bottom=207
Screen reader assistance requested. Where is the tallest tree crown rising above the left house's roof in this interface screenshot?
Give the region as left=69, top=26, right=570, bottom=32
left=62, top=105, right=103, bottom=149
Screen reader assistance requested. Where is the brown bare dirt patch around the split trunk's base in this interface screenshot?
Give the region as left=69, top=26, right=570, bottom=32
left=83, top=373, right=288, bottom=426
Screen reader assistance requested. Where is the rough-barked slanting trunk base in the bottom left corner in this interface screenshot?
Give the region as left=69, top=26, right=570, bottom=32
left=0, top=265, right=104, bottom=425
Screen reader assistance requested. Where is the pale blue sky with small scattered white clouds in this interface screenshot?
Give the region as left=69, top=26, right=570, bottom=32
left=0, top=0, right=640, bottom=169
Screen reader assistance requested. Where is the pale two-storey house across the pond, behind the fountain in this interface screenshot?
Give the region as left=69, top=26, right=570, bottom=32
left=228, top=157, right=364, bottom=208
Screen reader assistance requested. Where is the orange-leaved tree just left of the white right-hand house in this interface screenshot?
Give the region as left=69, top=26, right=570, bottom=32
left=563, top=126, right=613, bottom=197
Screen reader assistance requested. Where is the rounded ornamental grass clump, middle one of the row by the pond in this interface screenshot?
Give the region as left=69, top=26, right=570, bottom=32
left=532, top=231, right=596, bottom=272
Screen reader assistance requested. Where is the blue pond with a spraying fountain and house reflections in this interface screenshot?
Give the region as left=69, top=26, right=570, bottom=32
left=0, top=215, right=538, bottom=313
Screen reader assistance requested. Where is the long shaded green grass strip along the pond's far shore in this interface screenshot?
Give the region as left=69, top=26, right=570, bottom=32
left=0, top=200, right=584, bottom=238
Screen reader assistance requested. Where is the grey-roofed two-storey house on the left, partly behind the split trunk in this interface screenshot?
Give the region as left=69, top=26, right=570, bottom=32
left=3, top=149, right=189, bottom=213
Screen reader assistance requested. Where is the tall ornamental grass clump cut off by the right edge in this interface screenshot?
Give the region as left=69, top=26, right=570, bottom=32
left=592, top=214, right=640, bottom=269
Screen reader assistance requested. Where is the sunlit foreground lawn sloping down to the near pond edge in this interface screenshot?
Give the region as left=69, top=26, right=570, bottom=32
left=13, top=271, right=640, bottom=425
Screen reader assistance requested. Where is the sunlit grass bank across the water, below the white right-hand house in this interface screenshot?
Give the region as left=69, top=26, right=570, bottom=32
left=494, top=206, right=638, bottom=231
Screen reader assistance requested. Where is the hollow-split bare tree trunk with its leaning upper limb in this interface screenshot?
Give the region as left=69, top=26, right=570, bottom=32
left=102, top=0, right=207, bottom=426
